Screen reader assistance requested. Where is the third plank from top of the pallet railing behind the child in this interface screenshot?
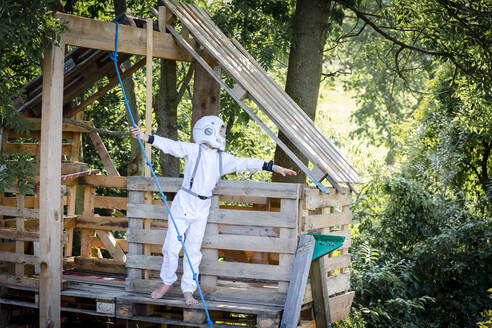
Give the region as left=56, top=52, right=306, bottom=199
left=127, top=229, right=297, bottom=254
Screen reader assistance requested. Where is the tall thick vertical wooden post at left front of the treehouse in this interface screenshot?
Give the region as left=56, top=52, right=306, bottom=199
left=39, top=36, right=65, bottom=328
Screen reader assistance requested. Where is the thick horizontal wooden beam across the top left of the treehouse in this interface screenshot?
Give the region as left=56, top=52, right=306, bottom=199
left=55, top=13, right=192, bottom=61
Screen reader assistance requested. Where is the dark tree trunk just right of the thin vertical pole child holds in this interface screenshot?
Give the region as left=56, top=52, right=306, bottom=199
left=154, top=59, right=180, bottom=177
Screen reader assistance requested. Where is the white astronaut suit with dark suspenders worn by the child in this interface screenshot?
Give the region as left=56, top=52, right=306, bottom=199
left=152, top=135, right=264, bottom=293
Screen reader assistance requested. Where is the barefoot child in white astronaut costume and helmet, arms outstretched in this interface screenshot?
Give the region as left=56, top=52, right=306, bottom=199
left=130, top=116, right=296, bottom=305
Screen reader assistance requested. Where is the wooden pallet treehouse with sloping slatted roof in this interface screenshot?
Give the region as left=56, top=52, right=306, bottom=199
left=0, top=0, right=361, bottom=327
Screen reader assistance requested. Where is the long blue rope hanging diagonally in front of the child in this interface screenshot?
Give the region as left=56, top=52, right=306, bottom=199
left=109, top=21, right=213, bottom=328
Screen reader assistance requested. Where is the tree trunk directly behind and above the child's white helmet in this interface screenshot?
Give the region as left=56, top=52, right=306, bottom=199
left=191, top=64, right=220, bottom=141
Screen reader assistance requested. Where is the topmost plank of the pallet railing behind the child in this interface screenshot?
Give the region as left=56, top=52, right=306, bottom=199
left=127, top=176, right=300, bottom=199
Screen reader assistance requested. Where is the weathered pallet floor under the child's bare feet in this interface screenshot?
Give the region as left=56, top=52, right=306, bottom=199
left=0, top=272, right=283, bottom=328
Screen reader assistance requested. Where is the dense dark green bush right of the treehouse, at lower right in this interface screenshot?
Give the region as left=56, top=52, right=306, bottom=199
left=340, top=169, right=492, bottom=327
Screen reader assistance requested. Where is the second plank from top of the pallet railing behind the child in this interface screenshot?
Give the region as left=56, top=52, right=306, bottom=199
left=127, top=204, right=297, bottom=228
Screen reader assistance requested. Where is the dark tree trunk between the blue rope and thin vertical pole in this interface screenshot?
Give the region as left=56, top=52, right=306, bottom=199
left=114, top=0, right=145, bottom=176
